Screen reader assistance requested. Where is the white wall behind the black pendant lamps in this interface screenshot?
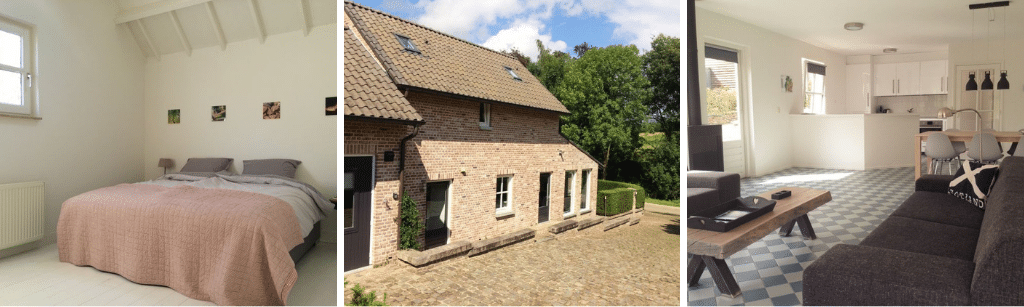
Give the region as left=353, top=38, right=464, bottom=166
left=945, top=38, right=1024, bottom=131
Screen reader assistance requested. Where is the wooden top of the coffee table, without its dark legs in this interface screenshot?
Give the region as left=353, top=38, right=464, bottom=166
left=686, top=187, right=831, bottom=259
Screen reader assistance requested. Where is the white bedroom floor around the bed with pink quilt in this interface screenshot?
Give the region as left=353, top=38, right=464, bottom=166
left=0, top=243, right=338, bottom=306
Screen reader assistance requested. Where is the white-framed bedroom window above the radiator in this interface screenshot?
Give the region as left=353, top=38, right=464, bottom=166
left=0, top=16, right=35, bottom=116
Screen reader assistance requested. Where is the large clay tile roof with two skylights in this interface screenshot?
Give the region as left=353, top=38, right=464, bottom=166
left=345, top=1, right=569, bottom=114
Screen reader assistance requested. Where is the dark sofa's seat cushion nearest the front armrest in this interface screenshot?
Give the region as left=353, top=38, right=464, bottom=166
left=860, top=216, right=978, bottom=261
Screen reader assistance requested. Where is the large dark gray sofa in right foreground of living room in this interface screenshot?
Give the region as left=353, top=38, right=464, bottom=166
left=803, top=157, right=1024, bottom=306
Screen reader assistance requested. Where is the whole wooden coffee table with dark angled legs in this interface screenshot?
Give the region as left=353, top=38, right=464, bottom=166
left=686, top=187, right=831, bottom=298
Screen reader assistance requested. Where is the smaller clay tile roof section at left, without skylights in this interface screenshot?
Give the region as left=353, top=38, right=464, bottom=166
left=344, top=24, right=423, bottom=122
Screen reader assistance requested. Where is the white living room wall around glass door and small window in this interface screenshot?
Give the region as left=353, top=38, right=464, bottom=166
left=695, top=8, right=846, bottom=176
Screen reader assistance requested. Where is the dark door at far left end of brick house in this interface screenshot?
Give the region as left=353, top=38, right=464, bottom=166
left=342, top=157, right=374, bottom=271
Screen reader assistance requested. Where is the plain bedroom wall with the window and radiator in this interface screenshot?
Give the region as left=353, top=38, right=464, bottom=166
left=0, top=0, right=144, bottom=257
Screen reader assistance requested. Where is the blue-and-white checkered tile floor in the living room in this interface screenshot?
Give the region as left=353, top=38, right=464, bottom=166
left=684, top=168, right=913, bottom=306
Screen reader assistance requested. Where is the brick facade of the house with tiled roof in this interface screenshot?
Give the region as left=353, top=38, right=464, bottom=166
left=344, top=92, right=598, bottom=264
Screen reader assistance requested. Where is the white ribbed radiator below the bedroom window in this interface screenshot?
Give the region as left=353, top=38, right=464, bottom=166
left=0, top=181, right=45, bottom=250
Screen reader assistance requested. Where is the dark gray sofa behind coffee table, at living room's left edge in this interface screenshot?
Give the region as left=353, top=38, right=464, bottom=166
left=686, top=171, right=739, bottom=214
